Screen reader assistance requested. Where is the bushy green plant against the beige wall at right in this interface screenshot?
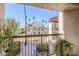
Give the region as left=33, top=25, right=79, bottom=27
left=55, top=39, right=73, bottom=56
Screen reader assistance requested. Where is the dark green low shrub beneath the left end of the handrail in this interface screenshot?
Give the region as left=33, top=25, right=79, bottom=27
left=5, top=42, right=21, bottom=56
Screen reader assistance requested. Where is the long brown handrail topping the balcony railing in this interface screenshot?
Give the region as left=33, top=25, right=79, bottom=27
left=12, top=34, right=62, bottom=38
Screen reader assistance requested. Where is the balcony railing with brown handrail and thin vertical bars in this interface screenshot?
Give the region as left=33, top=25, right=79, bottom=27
left=12, top=34, right=62, bottom=56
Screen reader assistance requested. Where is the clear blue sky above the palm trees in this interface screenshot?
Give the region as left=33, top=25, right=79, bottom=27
left=5, top=3, right=58, bottom=26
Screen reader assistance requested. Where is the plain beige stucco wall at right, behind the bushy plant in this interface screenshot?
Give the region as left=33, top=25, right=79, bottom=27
left=64, top=9, right=79, bottom=55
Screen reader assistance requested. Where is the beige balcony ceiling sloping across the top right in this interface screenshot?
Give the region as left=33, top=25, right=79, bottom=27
left=25, top=3, right=79, bottom=11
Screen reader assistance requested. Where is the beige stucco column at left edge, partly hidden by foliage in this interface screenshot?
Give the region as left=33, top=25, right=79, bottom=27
left=0, top=3, right=6, bottom=56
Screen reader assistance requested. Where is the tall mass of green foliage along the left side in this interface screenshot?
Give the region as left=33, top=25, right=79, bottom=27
left=0, top=19, right=20, bottom=55
